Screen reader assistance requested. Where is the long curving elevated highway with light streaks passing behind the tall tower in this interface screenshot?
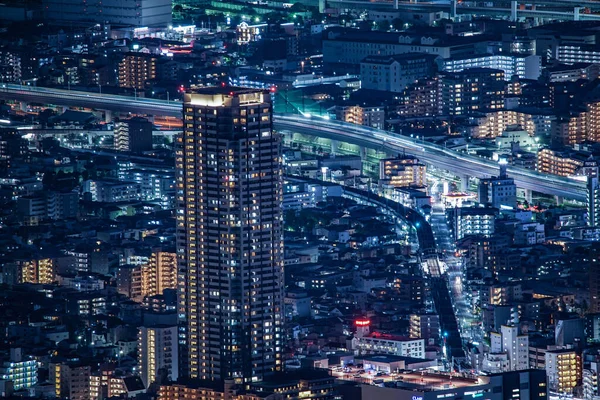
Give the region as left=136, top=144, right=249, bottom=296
left=0, top=84, right=586, bottom=201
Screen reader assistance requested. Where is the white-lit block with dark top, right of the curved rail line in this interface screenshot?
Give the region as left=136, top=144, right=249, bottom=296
left=448, top=207, right=498, bottom=240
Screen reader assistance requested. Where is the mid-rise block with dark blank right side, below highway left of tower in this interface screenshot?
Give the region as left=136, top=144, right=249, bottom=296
left=114, top=117, right=152, bottom=153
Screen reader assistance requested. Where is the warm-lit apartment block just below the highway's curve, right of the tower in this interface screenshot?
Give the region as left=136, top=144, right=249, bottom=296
left=379, top=155, right=427, bottom=187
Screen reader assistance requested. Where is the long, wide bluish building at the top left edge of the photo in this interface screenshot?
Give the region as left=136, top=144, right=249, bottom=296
left=42, top=0, right=172, bottom=28
